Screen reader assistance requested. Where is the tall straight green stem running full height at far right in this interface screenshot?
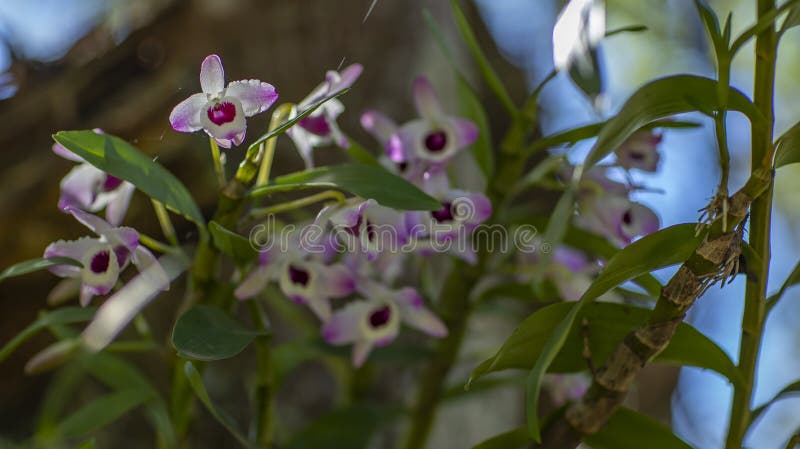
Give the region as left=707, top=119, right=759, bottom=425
left=725, top=0, right=777, bottom=449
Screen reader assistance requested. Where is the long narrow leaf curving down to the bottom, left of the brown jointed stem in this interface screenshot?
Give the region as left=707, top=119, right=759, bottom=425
left=526, top=223, right=701, bottom=442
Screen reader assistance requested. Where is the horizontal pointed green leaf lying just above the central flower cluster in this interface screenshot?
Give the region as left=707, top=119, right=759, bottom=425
left=250, top=164, right=442, bottom=210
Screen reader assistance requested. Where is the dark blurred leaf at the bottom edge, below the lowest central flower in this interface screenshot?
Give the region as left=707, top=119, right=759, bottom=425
left=286, top=404, right=392, bottom=449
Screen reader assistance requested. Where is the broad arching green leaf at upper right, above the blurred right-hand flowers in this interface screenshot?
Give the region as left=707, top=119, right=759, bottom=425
left=585, top=75, right=765, bottom=170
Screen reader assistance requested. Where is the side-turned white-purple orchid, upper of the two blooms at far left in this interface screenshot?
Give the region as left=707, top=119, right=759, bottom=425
left=53, top=129, right=136, bottom=226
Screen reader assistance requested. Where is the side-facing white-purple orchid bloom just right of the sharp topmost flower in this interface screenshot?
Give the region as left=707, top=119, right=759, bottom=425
left=286, top=64, right=363, bottom=168
